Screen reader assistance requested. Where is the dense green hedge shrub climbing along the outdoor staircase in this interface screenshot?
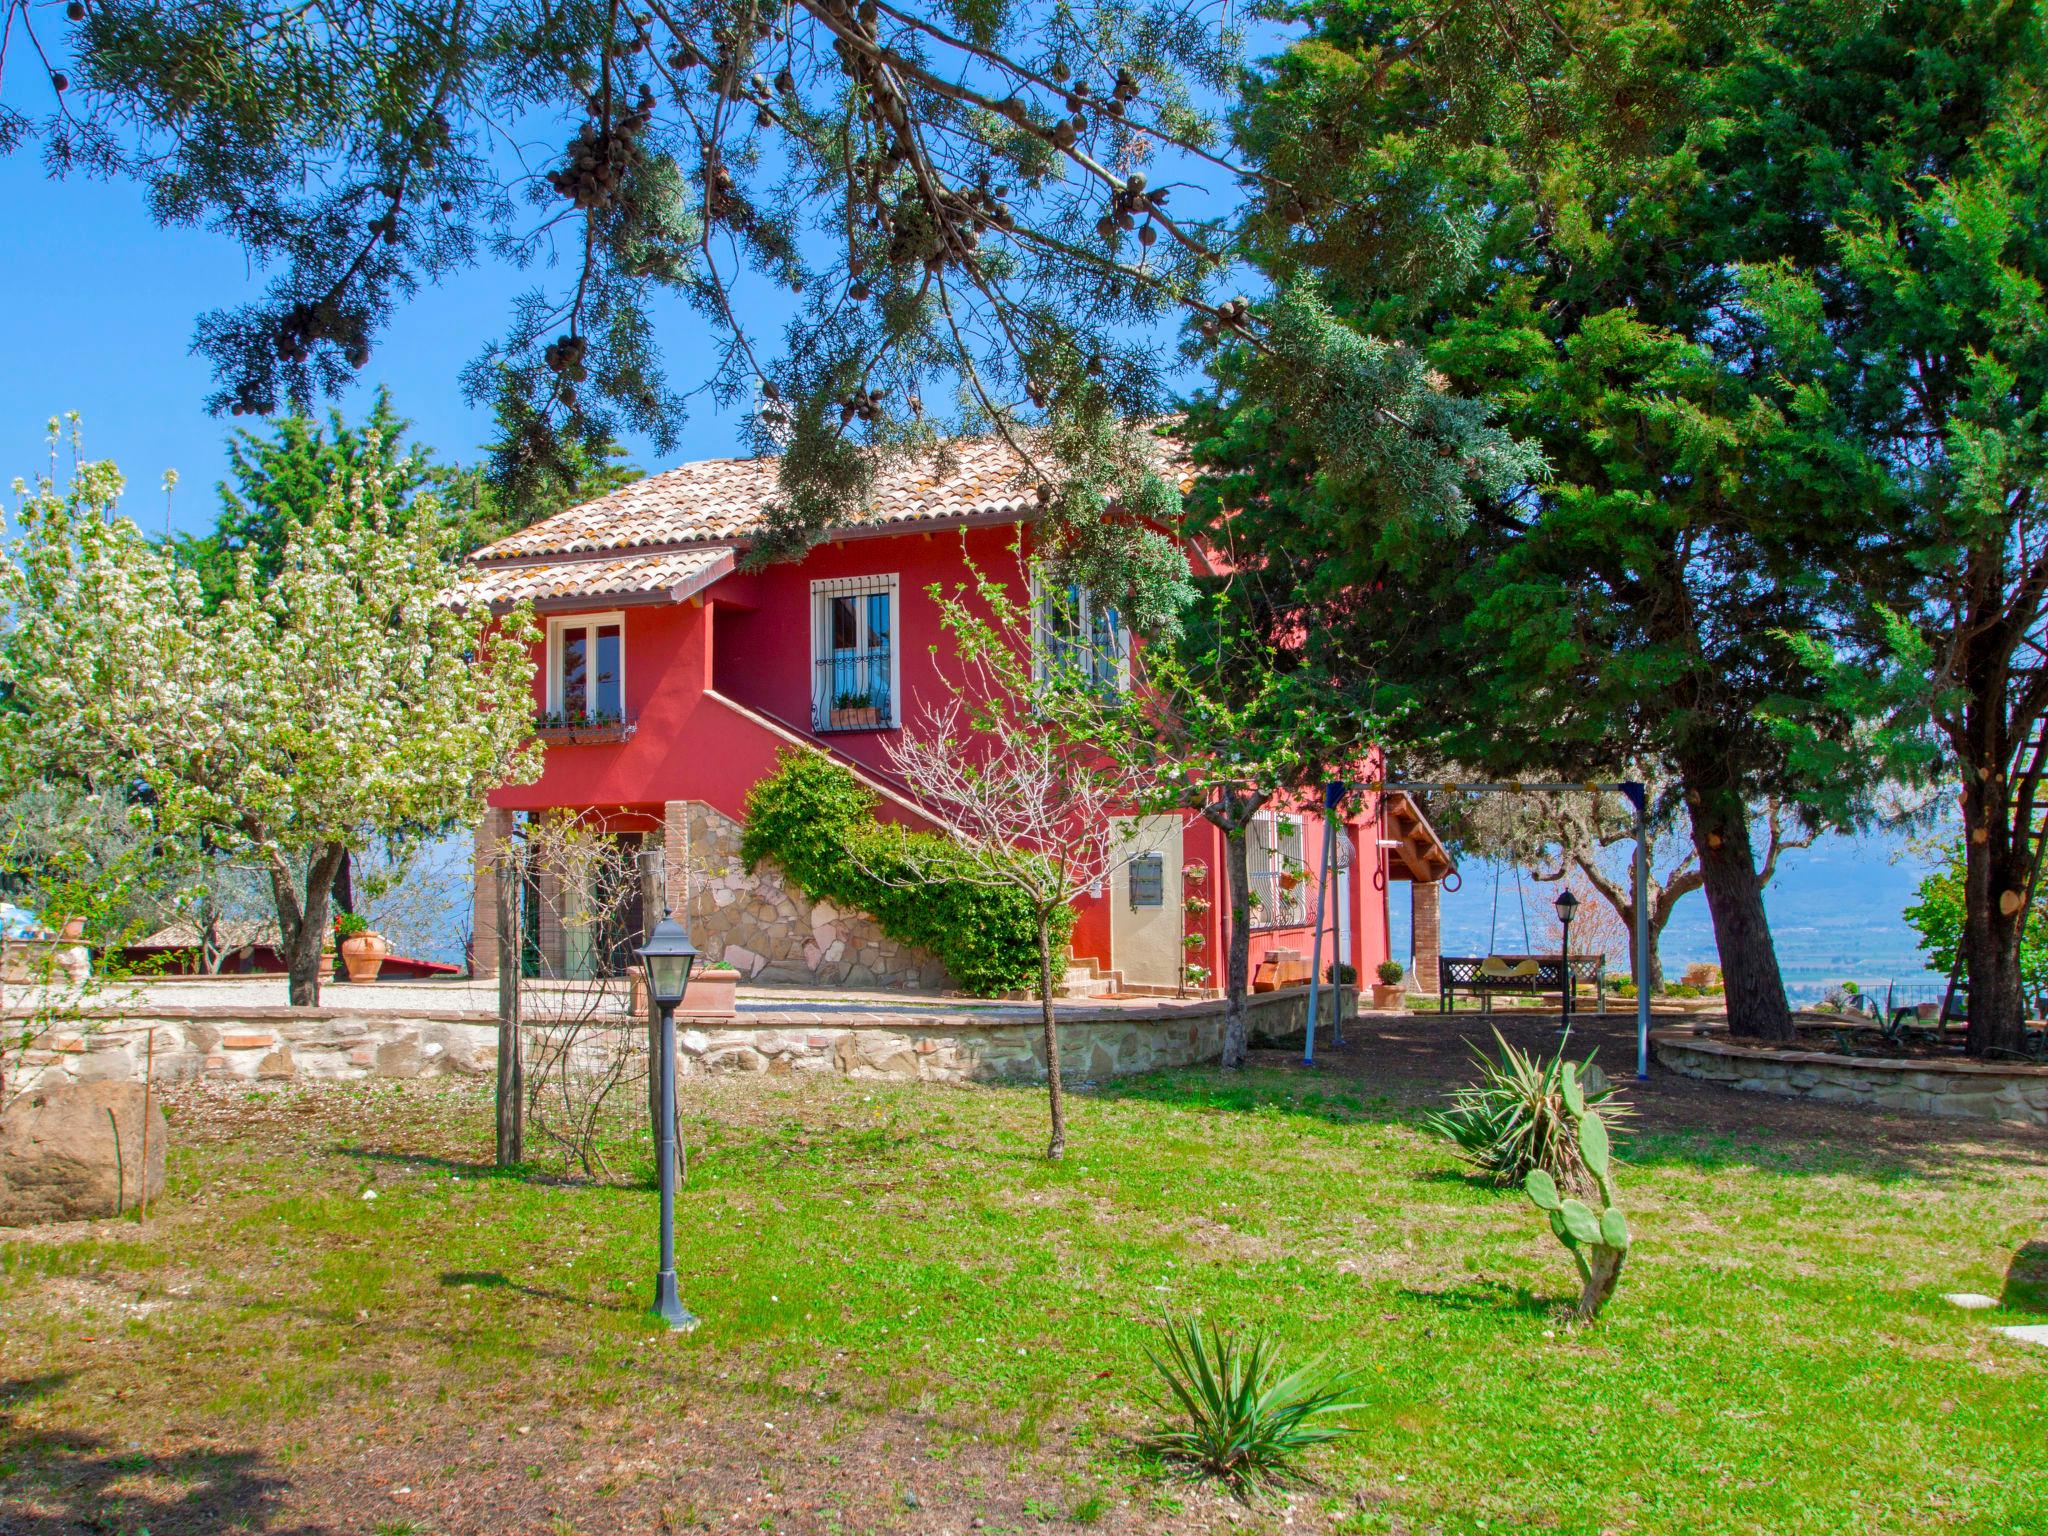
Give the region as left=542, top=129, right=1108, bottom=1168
left=739, top=748, right=1073, bottom=997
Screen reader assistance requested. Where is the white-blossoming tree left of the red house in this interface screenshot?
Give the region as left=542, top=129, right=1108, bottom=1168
left=0, top=463, right=539, bottom=1006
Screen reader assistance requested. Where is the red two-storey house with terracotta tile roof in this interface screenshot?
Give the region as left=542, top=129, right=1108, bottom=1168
left=465, top=440, right=1450, bottom=991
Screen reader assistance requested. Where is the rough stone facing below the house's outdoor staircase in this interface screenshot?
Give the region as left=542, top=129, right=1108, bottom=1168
left=668, top=801, right=952, bottom=991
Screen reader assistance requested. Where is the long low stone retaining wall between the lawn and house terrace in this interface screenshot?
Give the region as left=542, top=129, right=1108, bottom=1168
left=20, top=987, right=1350, bottom=1087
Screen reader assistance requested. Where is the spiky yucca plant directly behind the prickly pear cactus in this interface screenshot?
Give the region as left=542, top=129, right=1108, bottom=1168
left=1423, top=1030, right=1632, bottom=1190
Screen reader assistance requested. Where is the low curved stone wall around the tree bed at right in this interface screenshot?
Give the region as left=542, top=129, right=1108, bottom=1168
left=1651, top=1030, right=2048, bottom=1124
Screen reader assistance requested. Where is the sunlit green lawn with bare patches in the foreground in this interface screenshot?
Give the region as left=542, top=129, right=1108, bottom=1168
left=0, top=1047, right=2048, bottom=1536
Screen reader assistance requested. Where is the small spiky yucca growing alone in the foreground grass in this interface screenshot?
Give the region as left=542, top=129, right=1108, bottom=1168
left=1143, top=1321, right=1364, bottom=1495
